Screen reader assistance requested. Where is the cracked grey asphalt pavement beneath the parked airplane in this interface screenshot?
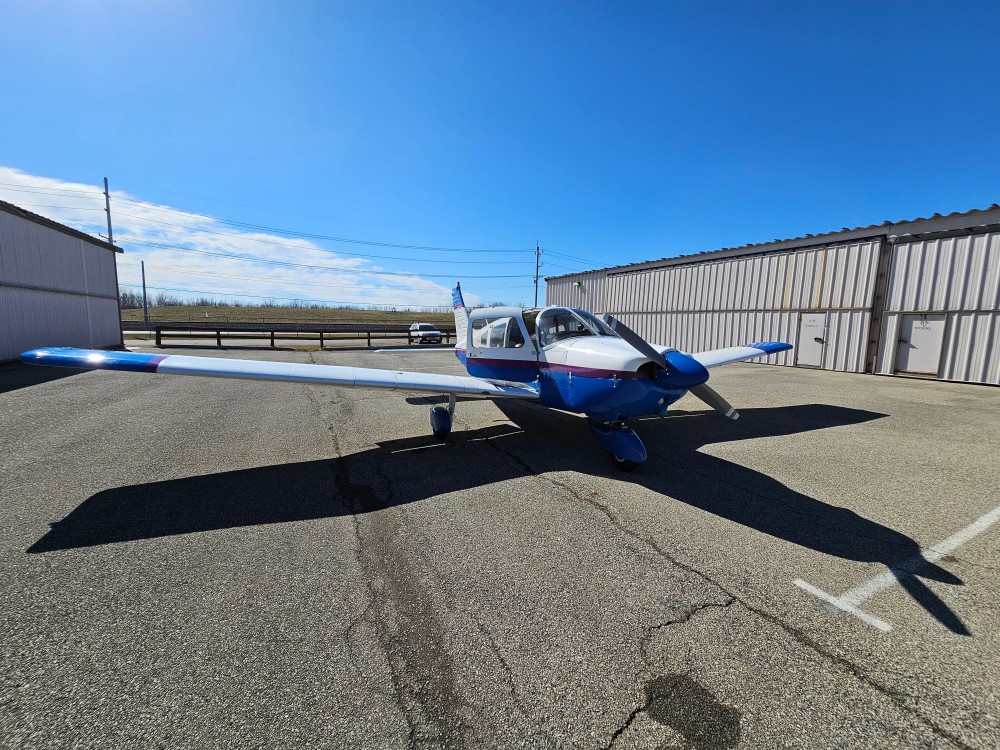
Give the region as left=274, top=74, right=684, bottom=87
left=0, top=351, right=1000, bottom=749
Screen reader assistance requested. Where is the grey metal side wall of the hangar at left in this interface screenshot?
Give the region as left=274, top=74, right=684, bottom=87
left=0, top=211, right=122, bottom=361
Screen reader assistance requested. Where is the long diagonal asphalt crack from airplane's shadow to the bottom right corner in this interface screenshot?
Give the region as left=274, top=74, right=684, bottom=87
left=489, top=442, right=972, bottom=750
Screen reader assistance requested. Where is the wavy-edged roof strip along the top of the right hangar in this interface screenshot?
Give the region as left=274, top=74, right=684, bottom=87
left=545, top=203, right=1000, bottom=281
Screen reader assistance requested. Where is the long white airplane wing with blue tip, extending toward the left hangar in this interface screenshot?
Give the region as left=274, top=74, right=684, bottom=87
left=21, top=347, right=538, bottom=399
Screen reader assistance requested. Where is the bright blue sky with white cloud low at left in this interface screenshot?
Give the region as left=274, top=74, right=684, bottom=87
left=0, top=0, right=1000, bottom=304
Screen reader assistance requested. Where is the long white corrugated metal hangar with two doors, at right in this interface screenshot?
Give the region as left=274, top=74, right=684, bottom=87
left=546, top=204, right=1000, bottom=385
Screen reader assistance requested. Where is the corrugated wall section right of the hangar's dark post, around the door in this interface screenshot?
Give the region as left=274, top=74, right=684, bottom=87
left=877, top=232, right=1000, bottom=385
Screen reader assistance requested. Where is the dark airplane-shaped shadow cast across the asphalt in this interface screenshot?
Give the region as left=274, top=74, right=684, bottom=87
left=27, top=398, right=969, bottom=635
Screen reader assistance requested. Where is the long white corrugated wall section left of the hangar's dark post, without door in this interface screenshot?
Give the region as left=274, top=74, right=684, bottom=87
left=547, top=239, right=880, bottom=372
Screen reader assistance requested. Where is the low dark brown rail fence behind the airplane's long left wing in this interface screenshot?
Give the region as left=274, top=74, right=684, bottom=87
left=122, top=321, right=455, bottom=349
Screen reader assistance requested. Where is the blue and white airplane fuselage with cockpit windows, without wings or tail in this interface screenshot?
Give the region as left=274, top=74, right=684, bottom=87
left=455, top=308, right=685, bottom=422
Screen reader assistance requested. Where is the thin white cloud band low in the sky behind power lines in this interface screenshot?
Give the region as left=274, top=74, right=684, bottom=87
left=0, top=166, right=478, bottom=308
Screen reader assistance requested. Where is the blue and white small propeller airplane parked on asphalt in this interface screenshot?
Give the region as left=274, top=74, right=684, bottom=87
left=21, top=283, right=792, bottom=471
